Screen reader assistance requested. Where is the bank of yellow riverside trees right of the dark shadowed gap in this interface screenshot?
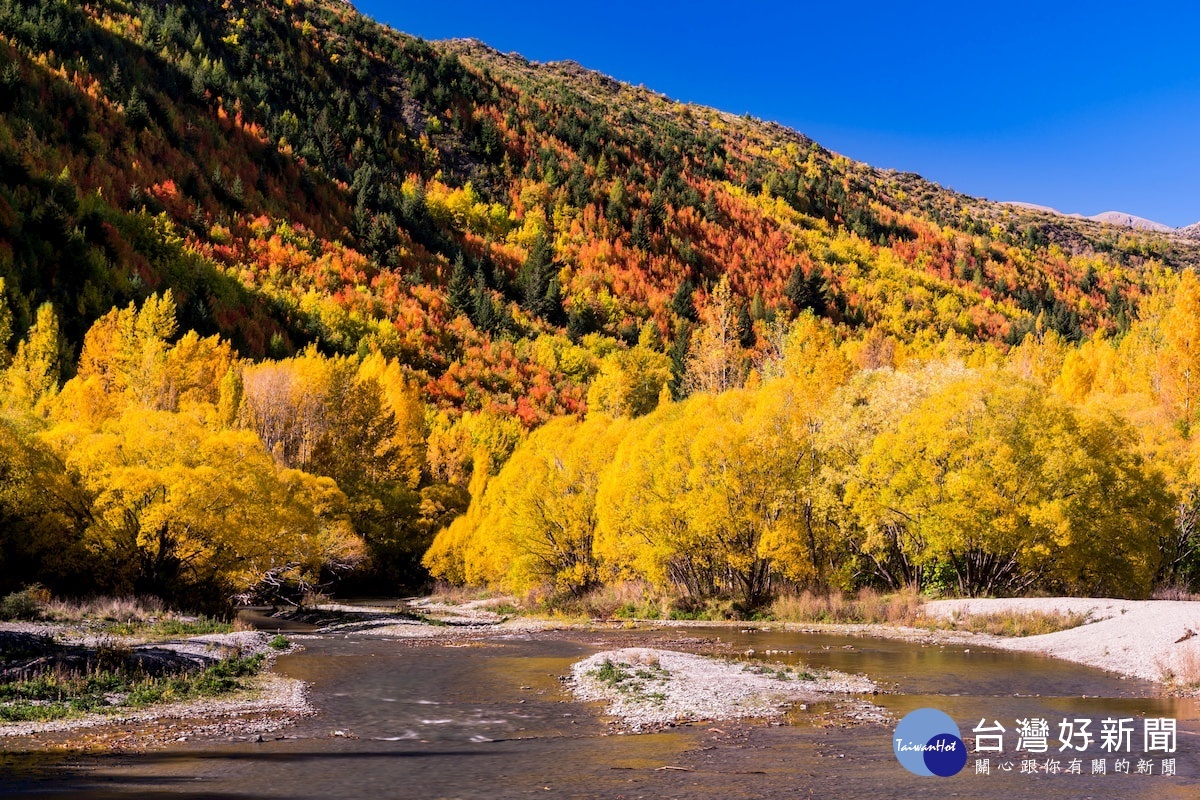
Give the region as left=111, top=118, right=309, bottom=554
left=425, top=271, right=1200, bottom=609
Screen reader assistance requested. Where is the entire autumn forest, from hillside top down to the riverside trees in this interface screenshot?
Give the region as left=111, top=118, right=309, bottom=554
left=0, top=0, right=1200, bottom=613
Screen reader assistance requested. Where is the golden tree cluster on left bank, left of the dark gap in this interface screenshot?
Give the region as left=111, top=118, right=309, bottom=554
left=0, top=293, right=464, bottom=602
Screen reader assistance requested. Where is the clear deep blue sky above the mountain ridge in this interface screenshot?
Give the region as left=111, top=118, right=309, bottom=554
left=356, top=0, right=1200, bottom=225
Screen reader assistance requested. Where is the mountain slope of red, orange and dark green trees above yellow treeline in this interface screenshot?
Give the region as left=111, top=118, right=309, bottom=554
left=0, top=0, right=1200, bottom=425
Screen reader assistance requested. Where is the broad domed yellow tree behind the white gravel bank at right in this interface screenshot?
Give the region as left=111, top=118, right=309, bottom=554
left=852, top=373, right=1170, bottom=595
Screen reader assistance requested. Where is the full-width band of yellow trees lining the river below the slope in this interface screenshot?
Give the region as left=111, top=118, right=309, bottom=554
left=7, top=262, right=1200, bottom=609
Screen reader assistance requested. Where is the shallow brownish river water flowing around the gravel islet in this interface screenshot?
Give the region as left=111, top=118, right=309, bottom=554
left=0, top=628, right=1200, bottom=800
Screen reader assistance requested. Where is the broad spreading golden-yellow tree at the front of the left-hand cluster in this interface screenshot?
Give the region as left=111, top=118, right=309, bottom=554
left=62, top=409, right=362, bottom=595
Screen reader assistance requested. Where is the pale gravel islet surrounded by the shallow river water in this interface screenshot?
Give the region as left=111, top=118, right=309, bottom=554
left=568, top=648, right=882, bottom=730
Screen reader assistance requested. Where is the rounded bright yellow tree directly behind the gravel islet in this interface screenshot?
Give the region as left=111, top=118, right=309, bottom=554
left=596, top=378, right=835, bottom=609
